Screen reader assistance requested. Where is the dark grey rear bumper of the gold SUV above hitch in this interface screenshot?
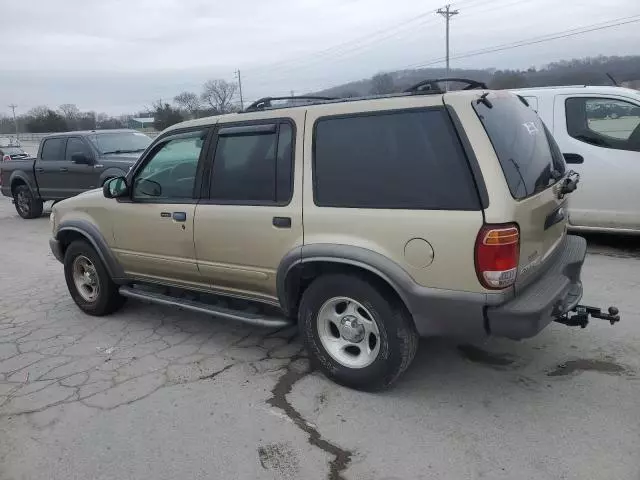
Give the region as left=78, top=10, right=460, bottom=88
left=485, top=235, right=587, bottom=339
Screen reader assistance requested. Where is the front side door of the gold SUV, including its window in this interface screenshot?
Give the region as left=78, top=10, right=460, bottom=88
left=112, top=129, right=209, bottom=287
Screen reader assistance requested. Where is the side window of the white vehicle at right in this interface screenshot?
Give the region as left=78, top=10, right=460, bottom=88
left=565, top=97, right=640, bottom=152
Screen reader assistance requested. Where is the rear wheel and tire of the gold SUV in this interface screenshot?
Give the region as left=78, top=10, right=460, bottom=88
left=298, top=274, right=418, bottom=391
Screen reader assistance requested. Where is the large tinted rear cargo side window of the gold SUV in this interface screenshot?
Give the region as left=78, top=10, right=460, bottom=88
left=313, top=108, right=480, bottom=210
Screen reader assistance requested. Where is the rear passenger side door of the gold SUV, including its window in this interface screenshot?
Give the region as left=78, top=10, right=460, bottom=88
left=194, top=115, right=304, bottom=301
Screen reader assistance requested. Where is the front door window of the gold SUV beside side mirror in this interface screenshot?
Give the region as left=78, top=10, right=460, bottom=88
left=133, top=131, right=206, bottom=200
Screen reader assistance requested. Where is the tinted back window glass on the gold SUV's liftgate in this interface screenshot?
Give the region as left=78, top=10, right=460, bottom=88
left=473, top=95, right=566, bottom=199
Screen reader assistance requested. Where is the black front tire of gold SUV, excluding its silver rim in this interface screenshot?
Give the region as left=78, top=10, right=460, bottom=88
left=64, top=240, right=126, bottom=317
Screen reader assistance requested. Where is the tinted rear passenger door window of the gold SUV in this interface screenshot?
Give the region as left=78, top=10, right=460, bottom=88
left=210, top=122, right=293, bottom=204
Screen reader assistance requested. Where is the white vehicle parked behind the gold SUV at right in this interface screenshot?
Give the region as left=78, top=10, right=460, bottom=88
left=512, top=86, right=640, bottom=233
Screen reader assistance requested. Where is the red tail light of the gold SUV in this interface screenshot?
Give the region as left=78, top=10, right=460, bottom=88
left=476, top=223, right=520, bottom=290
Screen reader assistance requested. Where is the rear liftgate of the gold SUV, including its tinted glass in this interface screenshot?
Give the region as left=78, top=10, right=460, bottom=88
left=472, top=92, right=567, bottom=288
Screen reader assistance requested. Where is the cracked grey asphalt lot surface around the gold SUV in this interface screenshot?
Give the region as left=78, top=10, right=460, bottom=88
left=0, top=198, right=640, bottom=480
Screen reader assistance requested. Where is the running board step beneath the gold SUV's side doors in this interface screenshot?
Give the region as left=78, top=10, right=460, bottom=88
left=119, top=285, right=293, bottom=328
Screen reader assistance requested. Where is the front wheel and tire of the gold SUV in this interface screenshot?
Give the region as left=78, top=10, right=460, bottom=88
left=64, top=240, right=125, bottom=316
